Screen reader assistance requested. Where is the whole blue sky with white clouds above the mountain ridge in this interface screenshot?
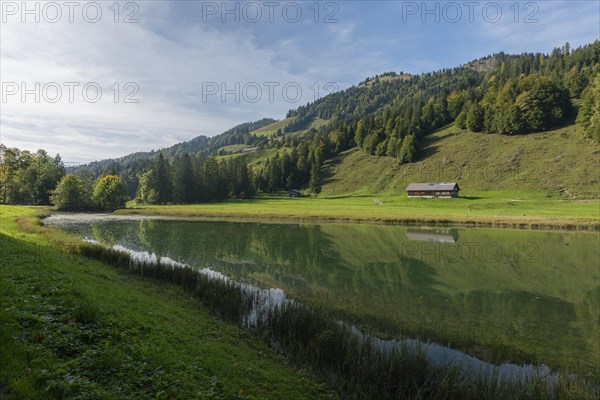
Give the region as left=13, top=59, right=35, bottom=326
left=0, top=0, right=600, bottom=163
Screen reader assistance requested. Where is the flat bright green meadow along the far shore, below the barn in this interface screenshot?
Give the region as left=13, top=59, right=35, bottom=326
left=117, top=191, right=600, bottom=230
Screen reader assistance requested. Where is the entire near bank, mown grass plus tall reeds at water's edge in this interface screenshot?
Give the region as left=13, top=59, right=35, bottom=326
left=0, top=208, right=596, bottom=399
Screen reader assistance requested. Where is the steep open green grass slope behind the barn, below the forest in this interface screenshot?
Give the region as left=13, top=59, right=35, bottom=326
left=322, top=124, right=600, bottom=199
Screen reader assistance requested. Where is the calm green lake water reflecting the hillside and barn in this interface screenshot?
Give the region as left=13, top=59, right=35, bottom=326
left=47, top=216, right=600, bottom=374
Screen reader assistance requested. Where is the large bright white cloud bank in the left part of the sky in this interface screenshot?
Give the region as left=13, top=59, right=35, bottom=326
left=0, top=3, right=314, bottom=161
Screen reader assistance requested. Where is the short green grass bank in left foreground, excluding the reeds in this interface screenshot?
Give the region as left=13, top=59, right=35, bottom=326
left=0, top=206, right=335, bottom=399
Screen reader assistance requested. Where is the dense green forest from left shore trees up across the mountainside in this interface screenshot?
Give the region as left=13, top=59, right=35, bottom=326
left=0, top=41, right=600, bottom=208
